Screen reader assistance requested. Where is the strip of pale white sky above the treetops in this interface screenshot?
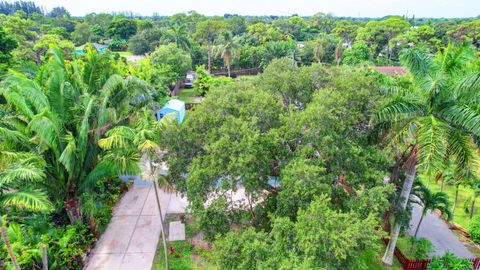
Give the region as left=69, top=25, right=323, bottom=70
left=27, top=0, right=480, bottom=18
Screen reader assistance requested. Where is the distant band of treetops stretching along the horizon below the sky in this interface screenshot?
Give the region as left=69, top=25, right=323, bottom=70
left=0, top=5, right=480, bottom=75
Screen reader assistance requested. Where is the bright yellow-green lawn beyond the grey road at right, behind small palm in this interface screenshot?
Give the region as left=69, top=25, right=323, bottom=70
left=425, top=178, right=480, bottom=229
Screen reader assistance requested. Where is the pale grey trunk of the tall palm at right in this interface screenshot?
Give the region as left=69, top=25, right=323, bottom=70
left=382, top=145, right=418, bottom=266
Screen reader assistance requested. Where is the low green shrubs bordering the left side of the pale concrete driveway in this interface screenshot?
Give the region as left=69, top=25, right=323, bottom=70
left=0, top=178, right=126, bottom=270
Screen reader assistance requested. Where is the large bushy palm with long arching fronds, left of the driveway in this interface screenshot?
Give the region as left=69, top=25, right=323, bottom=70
left=0, top=49, right=152, bottom=223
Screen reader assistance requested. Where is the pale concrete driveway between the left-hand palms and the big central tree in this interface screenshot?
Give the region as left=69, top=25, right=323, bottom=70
left=85, top=181, right=187, bottom=270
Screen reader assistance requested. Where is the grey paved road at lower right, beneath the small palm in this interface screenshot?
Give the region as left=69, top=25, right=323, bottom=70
left=408, top=204, right=475, bottom=258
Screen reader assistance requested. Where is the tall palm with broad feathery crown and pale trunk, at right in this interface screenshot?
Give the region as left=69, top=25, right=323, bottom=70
left=373, top=44, right=480, bottom=265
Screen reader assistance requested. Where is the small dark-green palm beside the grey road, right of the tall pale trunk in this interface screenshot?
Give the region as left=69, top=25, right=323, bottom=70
left=410, top=179, right=452, bottom=237
